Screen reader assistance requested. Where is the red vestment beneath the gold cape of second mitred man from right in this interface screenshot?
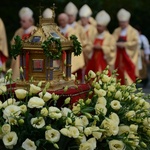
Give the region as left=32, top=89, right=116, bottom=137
left=85, top=39, right=107, bottom=74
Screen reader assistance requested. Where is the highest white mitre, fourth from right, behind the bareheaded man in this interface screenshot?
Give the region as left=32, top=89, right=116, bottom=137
left=64, top=2, right=78, bottom=16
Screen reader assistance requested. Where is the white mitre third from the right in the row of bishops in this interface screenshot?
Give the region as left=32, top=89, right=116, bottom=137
left=79, top=4, right=92, bottom=17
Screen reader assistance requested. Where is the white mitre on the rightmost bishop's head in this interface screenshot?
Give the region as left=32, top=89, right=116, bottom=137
left=117, top=8, right=131, bottom=21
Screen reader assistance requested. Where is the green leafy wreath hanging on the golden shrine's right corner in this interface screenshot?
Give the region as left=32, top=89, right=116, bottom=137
left=70, top=35, right=82, bottom=56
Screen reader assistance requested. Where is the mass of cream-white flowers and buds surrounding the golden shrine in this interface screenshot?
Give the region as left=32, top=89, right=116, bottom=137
left=0, top=69, right=150, bottom=150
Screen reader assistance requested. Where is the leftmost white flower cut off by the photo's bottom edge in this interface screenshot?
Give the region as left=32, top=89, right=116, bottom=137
left=22, top=138, right=37, bottom=150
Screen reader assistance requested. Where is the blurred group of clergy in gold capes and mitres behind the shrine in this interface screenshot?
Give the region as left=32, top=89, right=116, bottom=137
left=0, top=2, right=150, bottom=86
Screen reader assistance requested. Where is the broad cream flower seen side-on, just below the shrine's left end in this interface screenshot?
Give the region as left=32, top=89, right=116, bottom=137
left=28, top=96, right=45, bottom=108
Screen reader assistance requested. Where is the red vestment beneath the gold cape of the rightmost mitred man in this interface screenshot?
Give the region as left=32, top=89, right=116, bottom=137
left=115, top=36, right=136, bottom=84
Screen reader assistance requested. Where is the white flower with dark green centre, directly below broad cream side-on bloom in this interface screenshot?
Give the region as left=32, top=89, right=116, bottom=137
left=31, top=117, right=45, bottom=129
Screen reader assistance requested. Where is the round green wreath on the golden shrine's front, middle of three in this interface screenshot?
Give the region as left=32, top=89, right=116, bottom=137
left=42, top=37, right=62, bottom=59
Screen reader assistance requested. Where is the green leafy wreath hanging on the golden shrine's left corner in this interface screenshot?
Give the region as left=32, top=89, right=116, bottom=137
left=11, top=35, right=22, bottom=59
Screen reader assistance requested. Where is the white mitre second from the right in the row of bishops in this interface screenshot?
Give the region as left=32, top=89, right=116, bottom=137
left=95, top=10, right=110, bottom=26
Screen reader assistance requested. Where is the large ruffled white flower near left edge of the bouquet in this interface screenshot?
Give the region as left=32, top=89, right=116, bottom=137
left=3, top=105, right=21, bottom=119
